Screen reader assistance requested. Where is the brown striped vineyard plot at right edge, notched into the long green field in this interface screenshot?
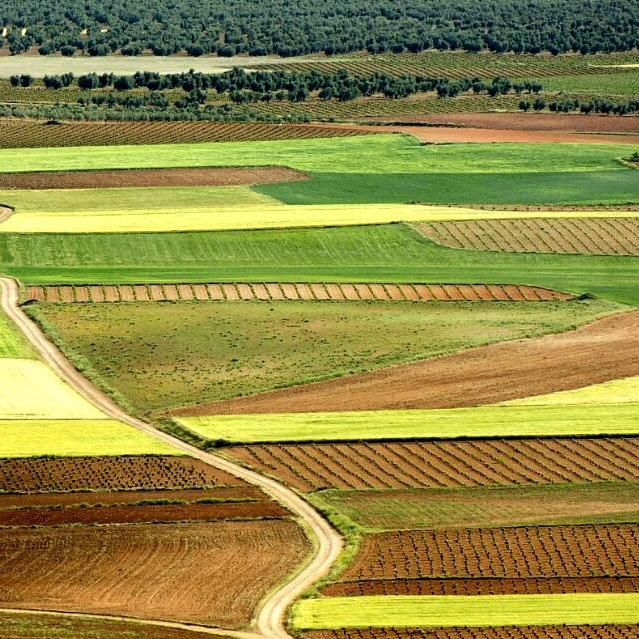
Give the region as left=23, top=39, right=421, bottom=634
left=416, top=218, right=639, bottom=255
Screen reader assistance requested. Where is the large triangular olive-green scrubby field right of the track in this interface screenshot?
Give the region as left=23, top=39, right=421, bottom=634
left=29, top=300, right=616, bottom=412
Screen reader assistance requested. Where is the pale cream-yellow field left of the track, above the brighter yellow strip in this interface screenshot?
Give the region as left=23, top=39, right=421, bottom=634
left=0, top=358, right=104, bottom=419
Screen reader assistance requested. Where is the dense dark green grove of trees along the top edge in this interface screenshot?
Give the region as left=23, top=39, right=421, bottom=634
left=0, top=0, right=639, bottom=56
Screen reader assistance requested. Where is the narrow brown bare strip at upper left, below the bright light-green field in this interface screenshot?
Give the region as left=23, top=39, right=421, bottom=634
left=0, top=166, right=308, bottom=189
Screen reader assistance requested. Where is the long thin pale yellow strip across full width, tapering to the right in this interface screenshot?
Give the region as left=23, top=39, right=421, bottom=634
left=0, top=204, right=637, bottom=233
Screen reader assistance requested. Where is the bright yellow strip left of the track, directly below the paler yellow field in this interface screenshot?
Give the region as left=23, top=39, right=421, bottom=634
left=0, top=419, right=181, bottom=457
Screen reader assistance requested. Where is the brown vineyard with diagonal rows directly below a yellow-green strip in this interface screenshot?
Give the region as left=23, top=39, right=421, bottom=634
left=224, top=438, right=639, bottom=492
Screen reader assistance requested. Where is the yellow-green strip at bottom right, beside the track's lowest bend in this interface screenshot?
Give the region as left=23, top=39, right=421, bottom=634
left=293, top=593, right=639, bottom=630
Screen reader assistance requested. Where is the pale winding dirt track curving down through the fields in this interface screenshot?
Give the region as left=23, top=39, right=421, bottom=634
left=0, top=277, right=343, bottom=639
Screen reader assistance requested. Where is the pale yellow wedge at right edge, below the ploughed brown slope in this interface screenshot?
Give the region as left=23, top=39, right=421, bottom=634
left=504, top=377, right=639, bottom=406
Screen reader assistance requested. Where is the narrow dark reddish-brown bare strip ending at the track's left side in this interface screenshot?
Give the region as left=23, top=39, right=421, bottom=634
left=0, top=501, right=287, bottom=527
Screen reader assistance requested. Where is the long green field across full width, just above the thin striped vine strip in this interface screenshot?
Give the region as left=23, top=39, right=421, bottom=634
left=0, top=224, right=639, bottom=305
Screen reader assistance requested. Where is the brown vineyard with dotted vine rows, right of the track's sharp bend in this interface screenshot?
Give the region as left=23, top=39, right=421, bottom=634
left=341, top=524, right=639, bottom=581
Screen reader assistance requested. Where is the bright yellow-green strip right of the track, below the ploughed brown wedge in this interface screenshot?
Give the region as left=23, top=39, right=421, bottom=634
left=178, top=404, right=639, bottom=445
